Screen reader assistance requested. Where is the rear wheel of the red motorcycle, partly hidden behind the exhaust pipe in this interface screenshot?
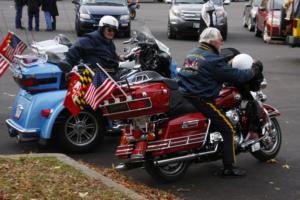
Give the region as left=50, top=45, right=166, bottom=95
left=145, top=161, right=189, bottom=183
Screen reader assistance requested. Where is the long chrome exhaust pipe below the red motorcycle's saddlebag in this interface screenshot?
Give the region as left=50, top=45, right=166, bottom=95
left=154, top=145, right=218, bottom=166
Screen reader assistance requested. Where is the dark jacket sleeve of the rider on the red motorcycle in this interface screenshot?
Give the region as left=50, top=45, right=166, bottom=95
left=213, top=57, right=254, bottom=84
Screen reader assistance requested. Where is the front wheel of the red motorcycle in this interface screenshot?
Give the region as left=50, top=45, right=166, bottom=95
left=251, top=118, right=282, bottom=162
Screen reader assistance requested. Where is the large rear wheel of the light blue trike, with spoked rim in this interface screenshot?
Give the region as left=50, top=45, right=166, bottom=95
left=54, top=110, right=106, bottom=153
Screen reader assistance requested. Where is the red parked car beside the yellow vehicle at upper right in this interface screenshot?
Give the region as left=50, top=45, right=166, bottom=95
left=255, top=0, right=284, bottom=42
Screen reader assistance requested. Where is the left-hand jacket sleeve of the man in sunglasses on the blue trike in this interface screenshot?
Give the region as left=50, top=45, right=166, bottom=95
left=66, top=37, right=92, bottom=66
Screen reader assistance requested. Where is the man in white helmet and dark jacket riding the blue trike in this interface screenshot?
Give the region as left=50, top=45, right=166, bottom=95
left=66, top=16, right=119, bottom=75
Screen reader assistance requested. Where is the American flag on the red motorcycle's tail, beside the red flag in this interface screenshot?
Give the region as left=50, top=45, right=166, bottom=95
left=84, top=69, right=117, bottom=110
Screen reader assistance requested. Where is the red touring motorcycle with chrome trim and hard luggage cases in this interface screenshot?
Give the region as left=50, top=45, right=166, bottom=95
left=102, top=71, right=281, bottom=182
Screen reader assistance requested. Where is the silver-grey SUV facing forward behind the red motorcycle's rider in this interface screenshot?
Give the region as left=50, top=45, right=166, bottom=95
left=168, top=0, right=227, bottom=40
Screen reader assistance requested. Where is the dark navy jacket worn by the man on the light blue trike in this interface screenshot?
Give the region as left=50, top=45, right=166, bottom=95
left=66, top=30, right=119, bottom=74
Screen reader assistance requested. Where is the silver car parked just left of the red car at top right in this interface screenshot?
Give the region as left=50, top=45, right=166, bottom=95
left=243, top=0, right=261, bottom=31
